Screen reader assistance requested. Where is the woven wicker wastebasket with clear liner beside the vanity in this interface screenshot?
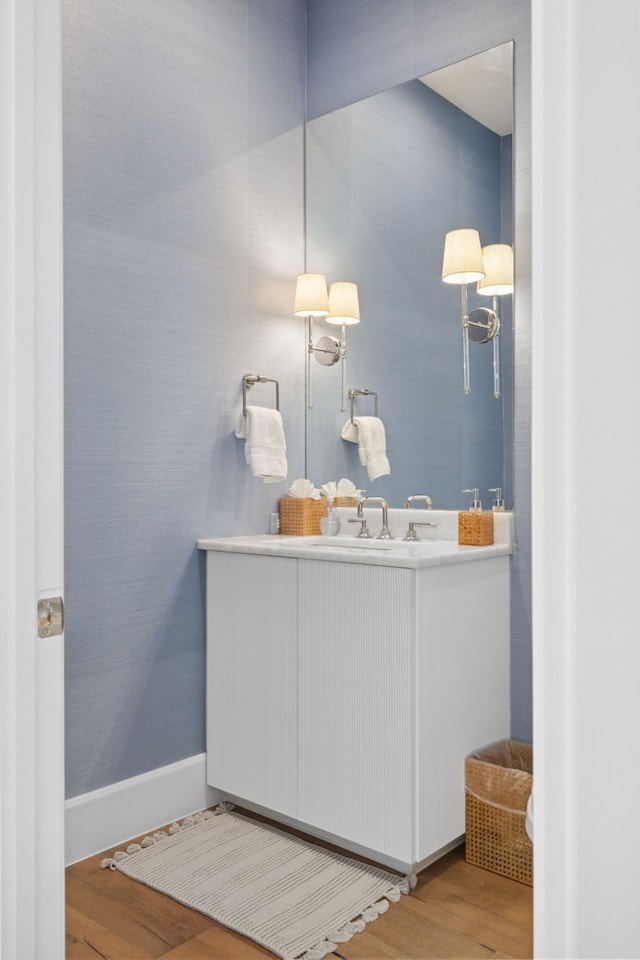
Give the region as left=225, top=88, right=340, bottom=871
left=465, top=740, right=533, bottom=886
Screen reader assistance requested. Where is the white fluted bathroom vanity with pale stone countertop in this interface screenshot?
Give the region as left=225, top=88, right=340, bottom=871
left=198, top=511, right=511, bottom=870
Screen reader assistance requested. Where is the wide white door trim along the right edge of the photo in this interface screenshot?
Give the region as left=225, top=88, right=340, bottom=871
left=531, top=0, right=640, bottom=960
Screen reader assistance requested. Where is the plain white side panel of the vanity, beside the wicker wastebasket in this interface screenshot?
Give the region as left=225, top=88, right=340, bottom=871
left=415, top=557, right=509, bottom=862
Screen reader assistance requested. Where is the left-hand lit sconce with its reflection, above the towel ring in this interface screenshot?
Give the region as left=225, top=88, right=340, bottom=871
left=293, top=273, right=360, bottom=410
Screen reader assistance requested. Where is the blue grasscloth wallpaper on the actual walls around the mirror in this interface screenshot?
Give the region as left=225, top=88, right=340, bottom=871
left=63, top=0, right=530, bottom=797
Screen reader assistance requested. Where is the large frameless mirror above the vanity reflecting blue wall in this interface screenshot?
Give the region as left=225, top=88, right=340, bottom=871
left=305, top=43, right=517, bottom=509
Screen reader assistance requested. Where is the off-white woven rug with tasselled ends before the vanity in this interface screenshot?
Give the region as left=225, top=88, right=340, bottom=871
left=101, top=804, right=415, bottom=960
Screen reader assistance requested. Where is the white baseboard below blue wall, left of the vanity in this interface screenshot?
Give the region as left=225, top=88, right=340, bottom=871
left=65, top=753, right=220, bottom=866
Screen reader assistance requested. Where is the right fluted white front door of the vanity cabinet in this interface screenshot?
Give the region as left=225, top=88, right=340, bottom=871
left=298, top=560, right=415, bottom=862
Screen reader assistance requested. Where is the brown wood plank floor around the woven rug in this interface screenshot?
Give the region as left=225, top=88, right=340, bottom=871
left=66, top=811, right=533, bottom=960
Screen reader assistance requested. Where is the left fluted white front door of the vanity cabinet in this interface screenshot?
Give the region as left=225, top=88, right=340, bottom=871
left=207, top=551, right=297, bottom=816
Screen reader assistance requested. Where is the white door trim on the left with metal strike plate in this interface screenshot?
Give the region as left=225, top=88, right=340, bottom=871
left=0, top=0, right=64, bottom=960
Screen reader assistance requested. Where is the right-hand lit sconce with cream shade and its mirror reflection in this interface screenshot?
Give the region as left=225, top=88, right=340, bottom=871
left=442, top=228, right=513, bottom=398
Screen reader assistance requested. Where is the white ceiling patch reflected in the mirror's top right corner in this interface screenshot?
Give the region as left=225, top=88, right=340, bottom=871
left=420, top=43, right=513, bottom=137
